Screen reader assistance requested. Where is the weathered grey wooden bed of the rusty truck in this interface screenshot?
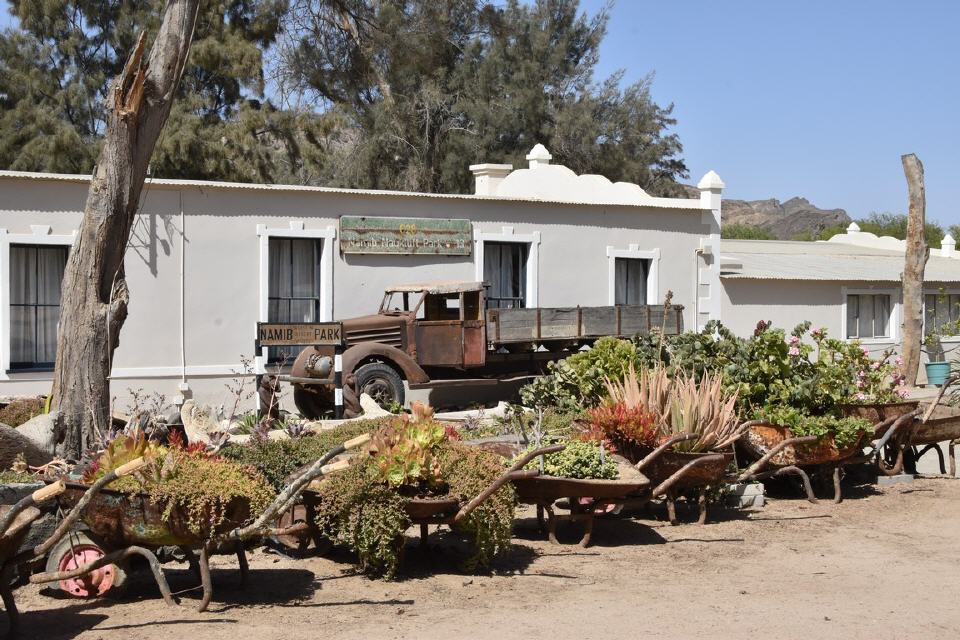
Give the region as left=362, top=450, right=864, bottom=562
left=487, top=305, right=683, bottom=347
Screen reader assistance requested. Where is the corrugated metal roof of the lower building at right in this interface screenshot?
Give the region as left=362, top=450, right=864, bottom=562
left=720, top=240, right=960, bottom=282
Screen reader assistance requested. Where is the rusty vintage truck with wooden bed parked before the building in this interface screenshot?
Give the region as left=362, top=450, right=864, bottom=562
left=285, top=282, right=683, bottom=419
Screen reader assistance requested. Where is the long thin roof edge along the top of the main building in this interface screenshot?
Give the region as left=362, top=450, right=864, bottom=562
left=0, top=170, right=703, bottom=211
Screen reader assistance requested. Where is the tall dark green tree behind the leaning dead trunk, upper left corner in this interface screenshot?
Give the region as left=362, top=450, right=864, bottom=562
left=0, top=0, right=319, bottom=181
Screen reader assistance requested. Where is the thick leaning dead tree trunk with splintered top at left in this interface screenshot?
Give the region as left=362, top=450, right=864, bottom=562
left=53, top=0, right=200, bottom=459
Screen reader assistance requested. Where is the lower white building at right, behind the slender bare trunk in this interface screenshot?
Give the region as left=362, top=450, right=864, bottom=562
left=720, top=223, right=960, bottom=376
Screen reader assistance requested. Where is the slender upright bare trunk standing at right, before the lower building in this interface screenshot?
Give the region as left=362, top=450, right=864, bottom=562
left=900, top=153, right=930, bottom=386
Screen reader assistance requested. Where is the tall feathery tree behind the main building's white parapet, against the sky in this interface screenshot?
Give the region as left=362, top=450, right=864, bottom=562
left=282, top=0, right=686, bottom=194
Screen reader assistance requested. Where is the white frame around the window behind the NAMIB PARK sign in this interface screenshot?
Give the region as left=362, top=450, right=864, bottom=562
left=251, top=220, right=337, bottom=374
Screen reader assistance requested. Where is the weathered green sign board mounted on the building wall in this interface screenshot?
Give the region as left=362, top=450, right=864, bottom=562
left=340, top=216, right=473, bottom=256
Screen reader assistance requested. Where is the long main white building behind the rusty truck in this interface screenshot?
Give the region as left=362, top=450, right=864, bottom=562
left=0, top=145, right=724, bottom=403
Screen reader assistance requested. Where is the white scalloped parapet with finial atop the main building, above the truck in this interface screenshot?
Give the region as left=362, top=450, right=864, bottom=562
left=488, top=144, right=704, bottom=209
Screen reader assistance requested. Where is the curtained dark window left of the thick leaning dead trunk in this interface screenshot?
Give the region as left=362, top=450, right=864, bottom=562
left=10, top=245, right=68, bottom=369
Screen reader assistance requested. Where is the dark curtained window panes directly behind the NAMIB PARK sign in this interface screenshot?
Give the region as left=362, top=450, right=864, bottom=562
left=267, top=237, right=322, bottom=362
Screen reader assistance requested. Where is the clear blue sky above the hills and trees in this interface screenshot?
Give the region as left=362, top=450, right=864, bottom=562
left=0, top=0, right=960, bottom=224
